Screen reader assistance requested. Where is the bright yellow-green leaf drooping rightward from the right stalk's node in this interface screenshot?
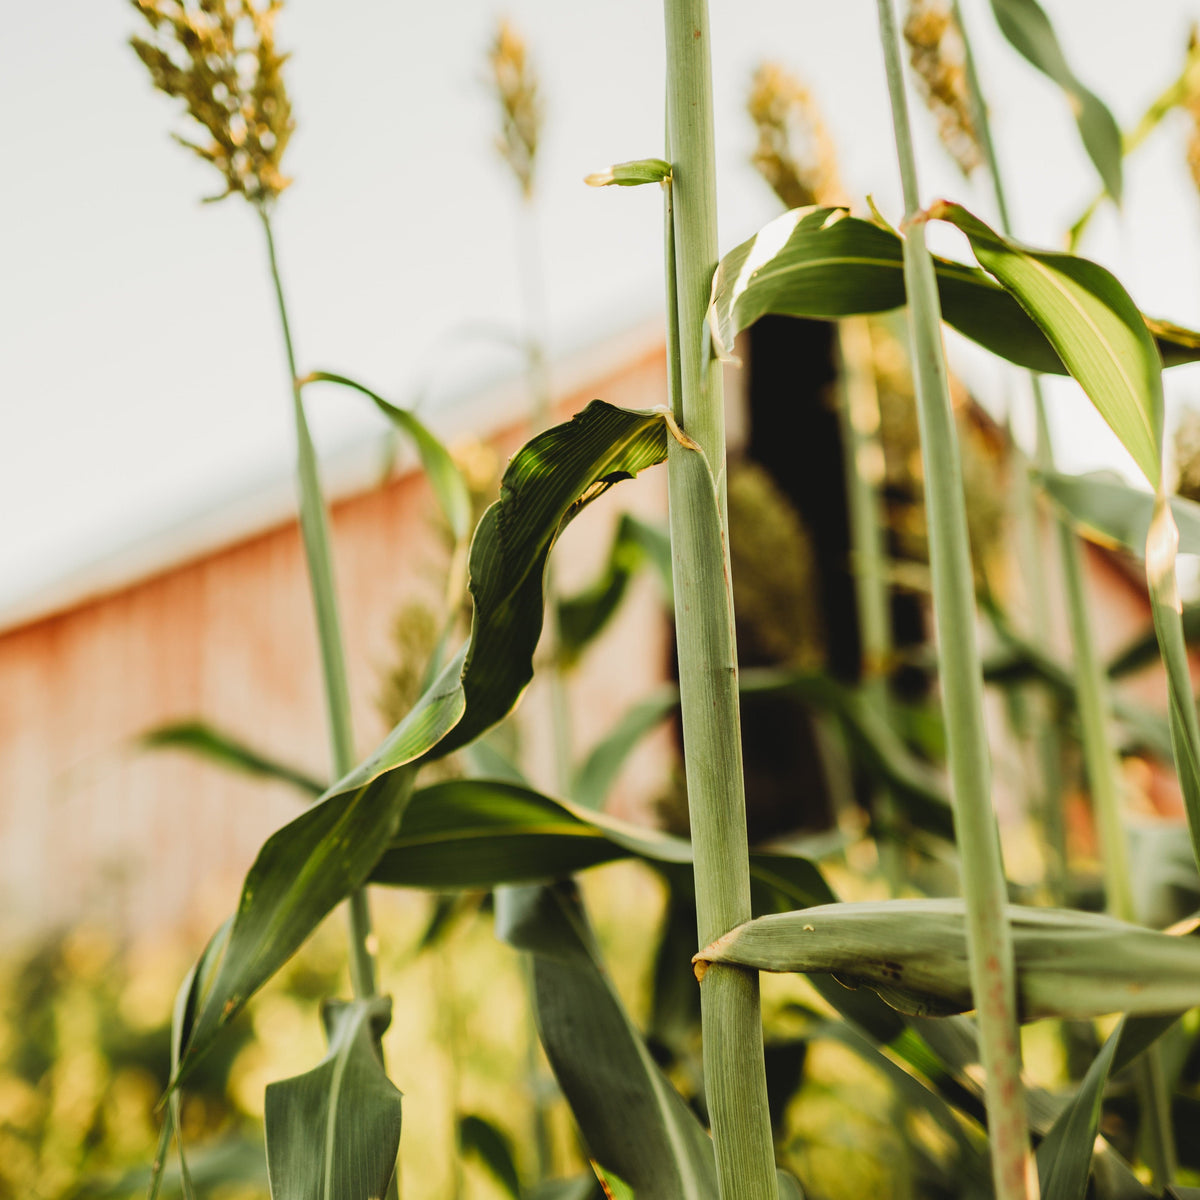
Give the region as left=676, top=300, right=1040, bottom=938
left=929, top=200, right=1163, bottom=487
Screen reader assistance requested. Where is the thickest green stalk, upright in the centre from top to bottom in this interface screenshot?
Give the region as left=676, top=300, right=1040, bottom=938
left=664, top=0, right=778, bottom=1200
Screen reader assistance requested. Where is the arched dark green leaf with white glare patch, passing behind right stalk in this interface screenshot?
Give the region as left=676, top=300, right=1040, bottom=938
left=708, top=208, right=1200, bottom=374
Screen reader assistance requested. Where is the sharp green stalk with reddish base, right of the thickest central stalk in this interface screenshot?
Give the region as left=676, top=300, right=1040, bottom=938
left=877, top=0, right=1038, bottom=1200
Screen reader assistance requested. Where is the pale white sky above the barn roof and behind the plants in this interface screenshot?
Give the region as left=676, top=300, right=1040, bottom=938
left=0, top=0, right=1200, bottom=608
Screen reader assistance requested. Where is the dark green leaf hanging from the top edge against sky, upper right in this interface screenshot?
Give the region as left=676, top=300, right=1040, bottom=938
left=991, top=0, right=1124, bottom=204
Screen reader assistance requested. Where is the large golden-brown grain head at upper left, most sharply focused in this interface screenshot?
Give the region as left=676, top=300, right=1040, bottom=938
left=130, top=0, right=295, bottom=204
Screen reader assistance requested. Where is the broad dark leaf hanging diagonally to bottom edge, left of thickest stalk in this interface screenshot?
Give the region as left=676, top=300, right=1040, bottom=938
left=496, top=884, right=718, bottom=1200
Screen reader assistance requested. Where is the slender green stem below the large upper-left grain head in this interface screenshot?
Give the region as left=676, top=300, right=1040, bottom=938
left=258, top=208, right=376, bottom=1000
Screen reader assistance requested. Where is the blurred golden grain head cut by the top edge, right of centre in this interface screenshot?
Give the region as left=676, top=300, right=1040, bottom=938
left=904, top=0, right=983, bottom=175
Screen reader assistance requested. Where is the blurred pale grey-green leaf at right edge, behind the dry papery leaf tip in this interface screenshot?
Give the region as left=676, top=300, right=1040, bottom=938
left=1037, top=472, right=1200, bottom=558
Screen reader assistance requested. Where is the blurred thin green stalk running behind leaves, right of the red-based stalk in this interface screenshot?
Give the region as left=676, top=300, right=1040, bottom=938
left=954, top=0, right=1177, bottom=1189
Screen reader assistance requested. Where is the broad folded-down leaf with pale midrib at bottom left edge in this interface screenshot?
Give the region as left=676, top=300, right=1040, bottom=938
left=264, top=996, right=401, bottom=1200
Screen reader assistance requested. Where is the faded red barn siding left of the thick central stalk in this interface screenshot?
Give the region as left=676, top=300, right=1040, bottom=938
left=0, top=346, right=668, bottom=934
